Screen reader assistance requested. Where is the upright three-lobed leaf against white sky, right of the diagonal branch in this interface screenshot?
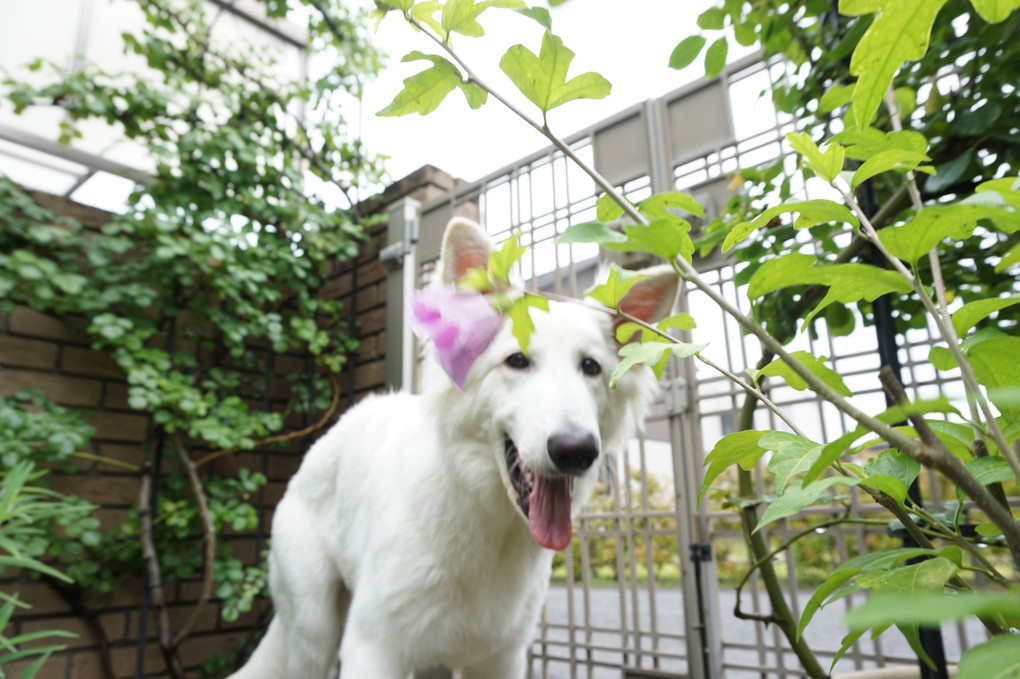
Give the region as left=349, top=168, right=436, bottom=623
left=500, top=32, right=612, bottom=114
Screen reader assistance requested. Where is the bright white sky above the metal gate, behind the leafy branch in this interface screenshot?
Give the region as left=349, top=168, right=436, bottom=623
left=350, top=0, right=709, bottom=185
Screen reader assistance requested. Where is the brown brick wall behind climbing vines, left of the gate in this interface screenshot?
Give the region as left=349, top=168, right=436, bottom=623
left=0, top=166, right=456, bottom=679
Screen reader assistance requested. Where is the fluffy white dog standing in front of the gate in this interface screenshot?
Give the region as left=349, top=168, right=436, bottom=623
left=234, top=219, right=677, bottom=679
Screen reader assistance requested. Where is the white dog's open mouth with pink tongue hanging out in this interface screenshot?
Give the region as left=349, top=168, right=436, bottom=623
left=505, top=436, right=574, bottom=552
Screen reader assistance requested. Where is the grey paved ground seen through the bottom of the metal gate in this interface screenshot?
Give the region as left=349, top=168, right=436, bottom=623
left=530, top=586, right=985, bottom=679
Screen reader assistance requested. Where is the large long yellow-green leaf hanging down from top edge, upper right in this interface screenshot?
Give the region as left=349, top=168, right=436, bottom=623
left=839, top=0, right=946, bottom=128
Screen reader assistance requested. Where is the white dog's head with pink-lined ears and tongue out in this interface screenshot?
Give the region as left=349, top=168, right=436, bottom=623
left=426, top=219, right=678, bottom=550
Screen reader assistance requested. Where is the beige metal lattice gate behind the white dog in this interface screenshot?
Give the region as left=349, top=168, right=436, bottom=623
left=383, top=56, right=984, bottom=679
